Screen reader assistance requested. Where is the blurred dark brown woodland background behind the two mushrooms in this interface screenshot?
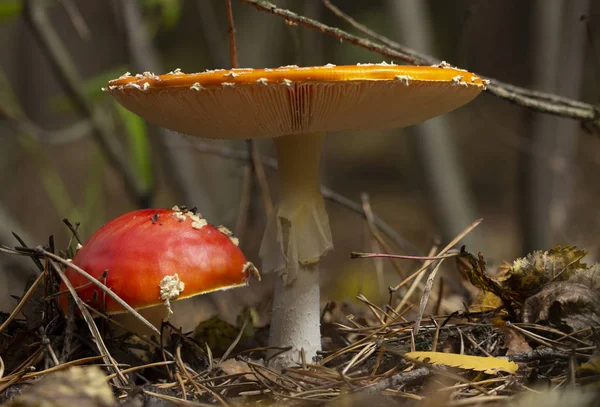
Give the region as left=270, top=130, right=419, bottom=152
left=0, top=0, right=600, bottom=321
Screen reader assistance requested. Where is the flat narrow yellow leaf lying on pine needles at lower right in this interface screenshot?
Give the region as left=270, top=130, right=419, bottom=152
left=405, top=352, right=519, bottom=374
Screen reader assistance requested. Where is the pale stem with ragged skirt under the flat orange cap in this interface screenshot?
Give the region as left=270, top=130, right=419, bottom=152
left=260, top=133, right=333, bottom=365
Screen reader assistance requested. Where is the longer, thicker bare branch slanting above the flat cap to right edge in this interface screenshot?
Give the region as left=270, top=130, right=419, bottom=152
left=241, top=0, right=600, bottom=128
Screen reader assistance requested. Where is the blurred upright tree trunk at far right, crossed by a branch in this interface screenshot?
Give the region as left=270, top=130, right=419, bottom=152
left=521, top=0, right=590, bottom=252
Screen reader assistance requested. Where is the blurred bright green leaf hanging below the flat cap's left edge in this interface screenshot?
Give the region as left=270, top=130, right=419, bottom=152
left=114, top=101, right=153, bottom=188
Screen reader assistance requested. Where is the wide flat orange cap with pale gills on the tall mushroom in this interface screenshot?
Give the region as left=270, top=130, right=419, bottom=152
left=104, top=64, right=486, bottom=139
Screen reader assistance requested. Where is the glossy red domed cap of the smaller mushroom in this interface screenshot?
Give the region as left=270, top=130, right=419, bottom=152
left=60, top=207, right=260, bottom=314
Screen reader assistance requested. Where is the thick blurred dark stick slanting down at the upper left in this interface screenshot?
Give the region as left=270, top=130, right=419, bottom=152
left=23, top=0, right=151, bottom=207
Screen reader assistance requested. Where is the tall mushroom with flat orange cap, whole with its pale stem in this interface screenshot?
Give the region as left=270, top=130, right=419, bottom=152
left=105, top=63, right=486, bottom=365
